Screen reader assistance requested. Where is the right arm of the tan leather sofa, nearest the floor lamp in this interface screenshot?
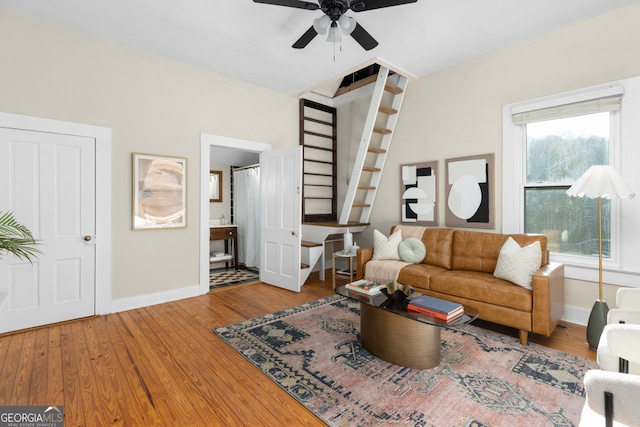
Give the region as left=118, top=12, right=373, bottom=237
left=531, top=263, right=564, bottom=336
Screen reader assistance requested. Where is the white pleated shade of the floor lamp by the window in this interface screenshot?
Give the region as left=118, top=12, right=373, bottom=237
left=567, top=165, right=636, bottom=199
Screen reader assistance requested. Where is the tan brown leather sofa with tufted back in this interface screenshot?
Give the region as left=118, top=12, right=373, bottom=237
left=356, top=225, right=564, bottom=345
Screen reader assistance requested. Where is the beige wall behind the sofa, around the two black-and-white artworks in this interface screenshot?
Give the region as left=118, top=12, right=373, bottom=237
left=345, top=2, right=640, bottom=320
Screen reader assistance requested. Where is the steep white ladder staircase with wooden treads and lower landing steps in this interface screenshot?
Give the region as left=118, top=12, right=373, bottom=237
left=300, top=66, right=408, bottom=285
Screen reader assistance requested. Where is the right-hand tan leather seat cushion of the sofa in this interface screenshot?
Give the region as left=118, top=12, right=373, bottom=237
left=432, top=272, right=533, bottom=312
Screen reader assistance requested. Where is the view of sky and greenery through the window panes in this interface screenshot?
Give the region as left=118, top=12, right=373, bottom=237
left=524, top=111, right=614, bottom=258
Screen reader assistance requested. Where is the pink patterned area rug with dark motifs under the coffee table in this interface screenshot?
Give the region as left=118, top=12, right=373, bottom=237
left=215, top=295, right=596, bottom=427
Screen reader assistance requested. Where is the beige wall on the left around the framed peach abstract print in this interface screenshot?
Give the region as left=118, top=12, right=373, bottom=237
left=0, top=9, right=298, bottom=299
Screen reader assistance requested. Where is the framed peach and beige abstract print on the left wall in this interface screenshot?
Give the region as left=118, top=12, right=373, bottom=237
left=131, top=153, right=187, bottom=230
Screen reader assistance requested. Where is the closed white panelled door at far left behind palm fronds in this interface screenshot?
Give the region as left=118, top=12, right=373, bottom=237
left=0, top=128, right=96, bottom=333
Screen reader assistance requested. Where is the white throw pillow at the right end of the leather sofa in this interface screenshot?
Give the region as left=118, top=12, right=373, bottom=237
left=493, top=237, right=542, bottom=289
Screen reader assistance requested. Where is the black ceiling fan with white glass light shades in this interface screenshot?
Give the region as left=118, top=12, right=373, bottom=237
left=253, top=0, right=418, bottom=50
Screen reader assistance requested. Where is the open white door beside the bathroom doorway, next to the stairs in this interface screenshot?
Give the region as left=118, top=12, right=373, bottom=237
left=260, top=146, right=302, bottom=292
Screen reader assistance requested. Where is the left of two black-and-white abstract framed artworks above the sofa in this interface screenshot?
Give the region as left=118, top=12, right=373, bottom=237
left=400, top=160, right=438, bottom=226
